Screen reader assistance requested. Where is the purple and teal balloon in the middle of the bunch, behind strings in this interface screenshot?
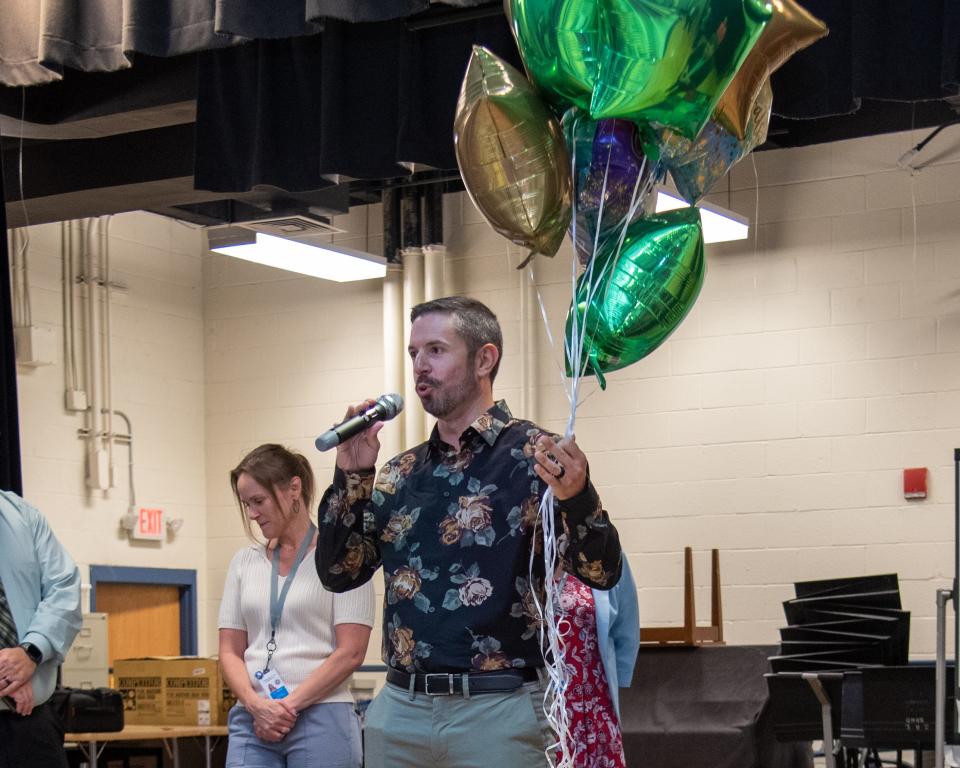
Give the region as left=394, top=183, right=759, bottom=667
left=563, top=110, right=653, bottom=265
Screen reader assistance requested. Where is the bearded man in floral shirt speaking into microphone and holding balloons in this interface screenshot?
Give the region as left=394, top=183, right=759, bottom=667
left=316, top=297, right=621, bottom=768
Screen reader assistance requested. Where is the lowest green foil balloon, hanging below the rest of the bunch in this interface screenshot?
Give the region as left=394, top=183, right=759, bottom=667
left=566, top=207, right=704, bottom=388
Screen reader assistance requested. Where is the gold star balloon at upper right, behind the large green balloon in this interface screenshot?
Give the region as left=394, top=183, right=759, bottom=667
left=714, top=0, right=828, bottom=139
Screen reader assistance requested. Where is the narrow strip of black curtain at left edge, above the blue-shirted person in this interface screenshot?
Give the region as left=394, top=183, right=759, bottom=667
left=0, top=155, right=23, bottom=495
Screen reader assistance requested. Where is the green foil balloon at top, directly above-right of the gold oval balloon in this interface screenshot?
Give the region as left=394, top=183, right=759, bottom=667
left=503, top=0, right=600, bottom=112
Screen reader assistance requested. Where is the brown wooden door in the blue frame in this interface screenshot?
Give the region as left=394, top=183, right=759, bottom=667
left=97, top=583, right=180, bottom=667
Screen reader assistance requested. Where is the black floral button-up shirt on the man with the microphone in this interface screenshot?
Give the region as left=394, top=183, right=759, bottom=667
left=316, top=401, right=620, bottom=672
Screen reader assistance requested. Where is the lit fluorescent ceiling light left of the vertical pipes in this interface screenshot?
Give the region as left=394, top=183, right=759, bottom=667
left=210, top=232, right=387, bottom=283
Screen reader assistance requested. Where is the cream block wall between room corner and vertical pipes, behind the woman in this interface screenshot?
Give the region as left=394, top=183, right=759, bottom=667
left=204, top=206, right=384, bottom=663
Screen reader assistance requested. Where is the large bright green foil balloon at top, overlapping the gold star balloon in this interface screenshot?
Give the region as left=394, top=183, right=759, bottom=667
left=590, top=0, right=772, bottom=139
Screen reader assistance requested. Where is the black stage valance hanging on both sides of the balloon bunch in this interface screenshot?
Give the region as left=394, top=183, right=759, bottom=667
left=195, top=0, right=960, bottom=192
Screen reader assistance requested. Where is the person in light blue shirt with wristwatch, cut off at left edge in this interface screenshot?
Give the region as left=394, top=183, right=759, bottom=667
left=0, top=491, right=82, bottom=768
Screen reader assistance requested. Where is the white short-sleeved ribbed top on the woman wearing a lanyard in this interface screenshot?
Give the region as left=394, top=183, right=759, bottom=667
left=217, top=544, right=375, bottom=702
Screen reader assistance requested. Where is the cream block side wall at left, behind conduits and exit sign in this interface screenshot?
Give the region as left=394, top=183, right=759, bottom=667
left=17, top=213, right=207, bottom=626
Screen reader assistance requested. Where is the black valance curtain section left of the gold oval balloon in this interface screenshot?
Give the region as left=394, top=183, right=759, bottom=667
left=195, top=16, right=520, bottom=192
